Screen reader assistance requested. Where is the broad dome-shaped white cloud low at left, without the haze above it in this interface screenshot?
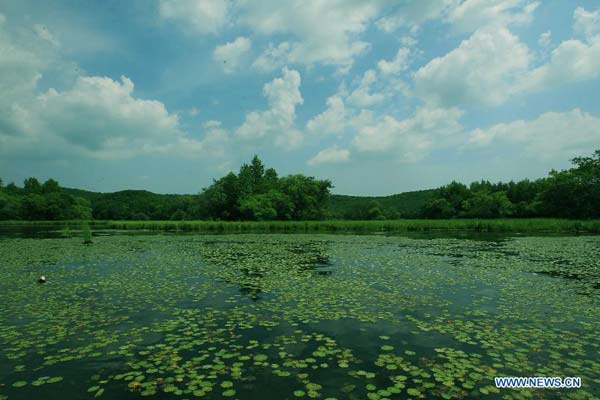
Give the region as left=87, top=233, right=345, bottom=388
left=0, top=72, right=229, bottom=159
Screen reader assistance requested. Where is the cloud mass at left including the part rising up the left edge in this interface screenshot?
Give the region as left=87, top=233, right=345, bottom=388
left=0, top=15, right=227, bottom=158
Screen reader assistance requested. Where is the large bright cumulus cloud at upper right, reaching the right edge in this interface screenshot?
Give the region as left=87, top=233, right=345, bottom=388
left=414, top=7, right=600, bottom=107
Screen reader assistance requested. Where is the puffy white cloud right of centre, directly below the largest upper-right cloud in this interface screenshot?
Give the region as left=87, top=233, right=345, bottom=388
left=353, top=108, right=463, bottom=162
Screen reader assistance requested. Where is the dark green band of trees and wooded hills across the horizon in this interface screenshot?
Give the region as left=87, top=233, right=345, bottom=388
left=0, top=150, right=600, bottom=221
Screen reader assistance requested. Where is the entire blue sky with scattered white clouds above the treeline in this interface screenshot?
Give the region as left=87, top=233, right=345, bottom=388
left=0, top=0, right=600, bottom=195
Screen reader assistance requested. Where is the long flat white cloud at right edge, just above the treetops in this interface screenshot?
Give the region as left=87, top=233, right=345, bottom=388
left=468, top=109, right=600, bottom=159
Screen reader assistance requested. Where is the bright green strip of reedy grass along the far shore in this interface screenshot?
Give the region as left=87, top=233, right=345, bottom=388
left=0, top=218, right=600, bottom=233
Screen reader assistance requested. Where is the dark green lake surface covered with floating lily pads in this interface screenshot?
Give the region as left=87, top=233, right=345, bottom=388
left=0, top=232, right=600, bottom=400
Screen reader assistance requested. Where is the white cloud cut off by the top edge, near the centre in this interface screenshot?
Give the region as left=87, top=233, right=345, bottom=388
left=238, top=0, right=380, bottom=70
